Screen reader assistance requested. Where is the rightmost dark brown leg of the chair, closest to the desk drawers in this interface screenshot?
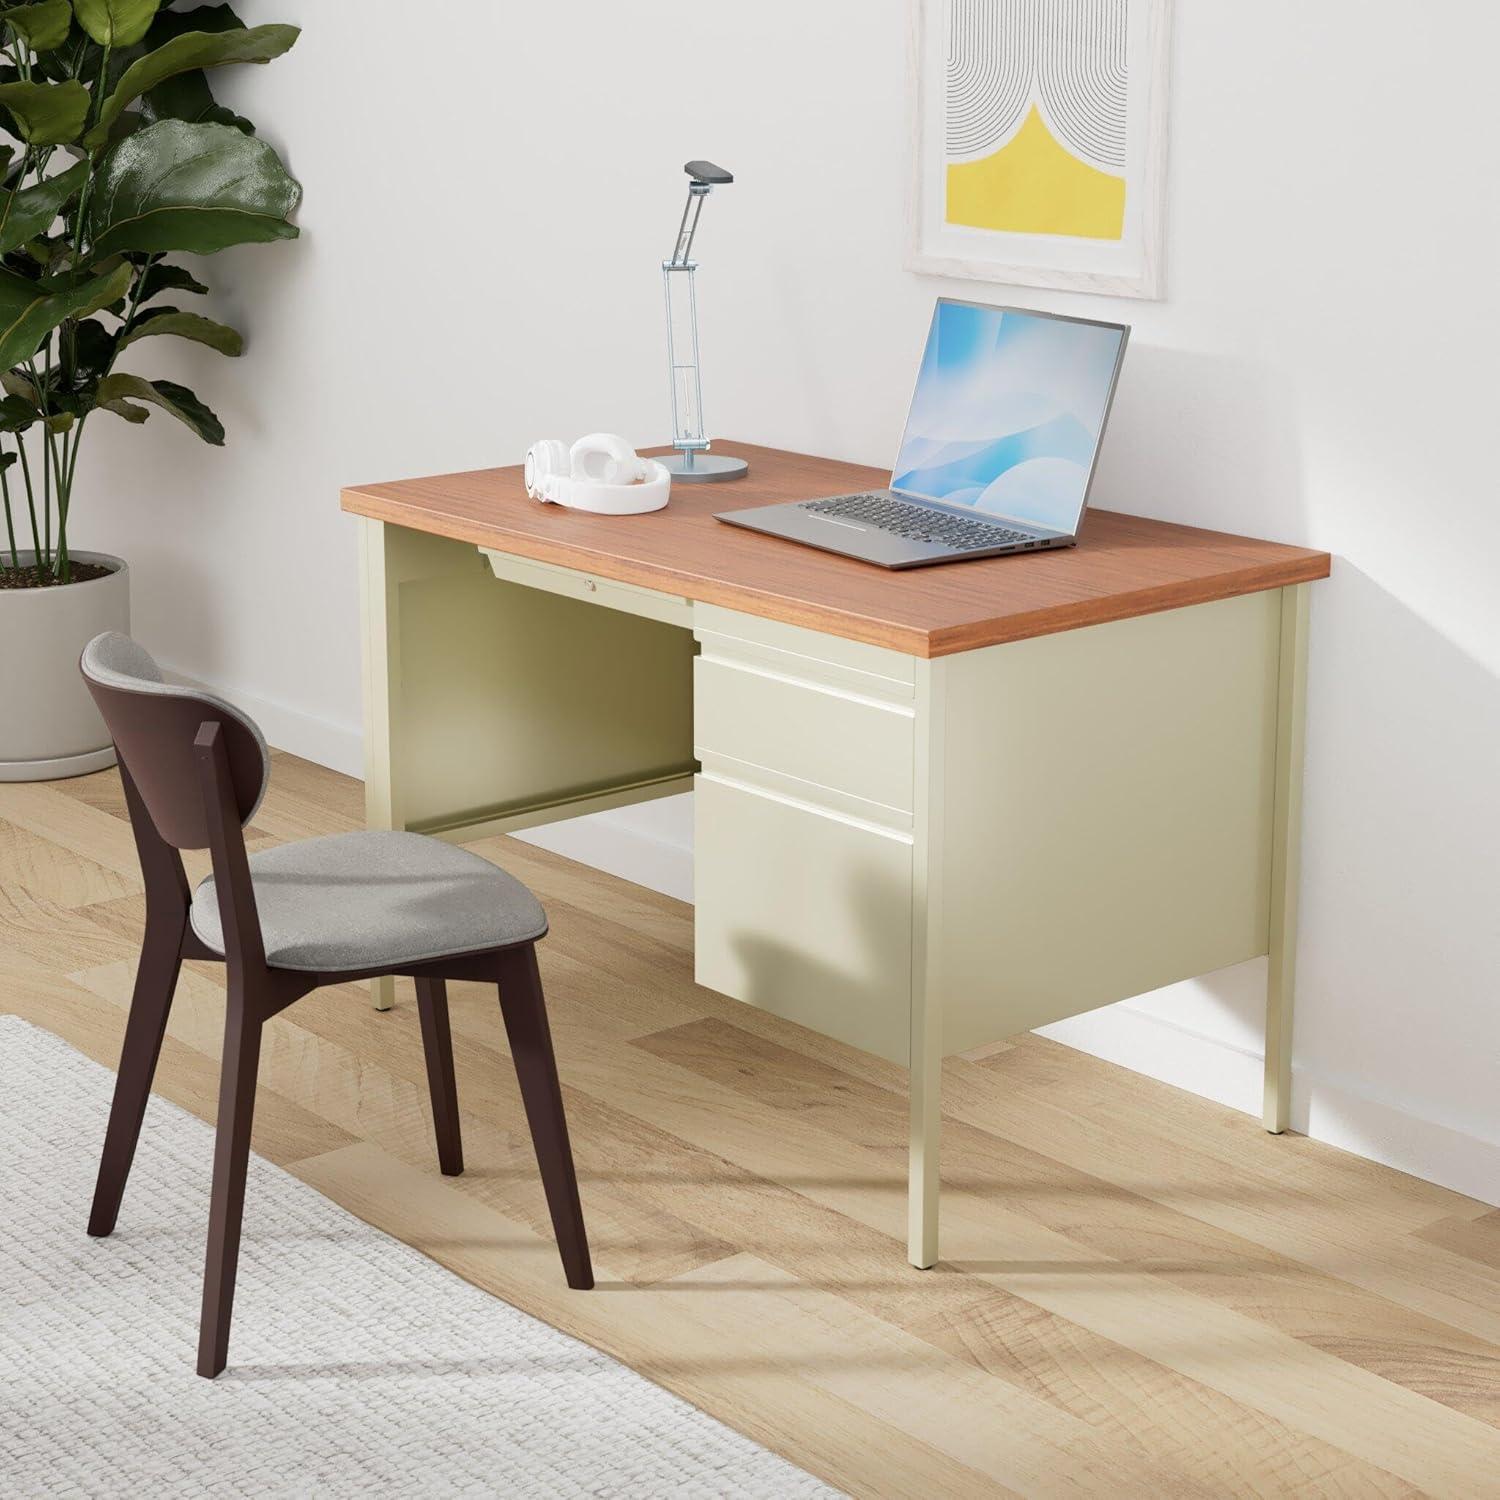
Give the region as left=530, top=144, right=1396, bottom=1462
left=500, top=944, right=594, bottom=1292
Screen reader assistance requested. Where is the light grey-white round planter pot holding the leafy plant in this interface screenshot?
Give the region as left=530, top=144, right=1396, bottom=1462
left=0, top=552, right=131, bottom=782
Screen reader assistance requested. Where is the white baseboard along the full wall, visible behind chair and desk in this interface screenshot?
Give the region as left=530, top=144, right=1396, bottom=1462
left=184, top=674, right=1500, bottom=1205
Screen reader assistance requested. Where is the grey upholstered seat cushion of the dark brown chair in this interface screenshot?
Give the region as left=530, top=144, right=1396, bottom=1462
left=191, top=833, right=548, bottom=969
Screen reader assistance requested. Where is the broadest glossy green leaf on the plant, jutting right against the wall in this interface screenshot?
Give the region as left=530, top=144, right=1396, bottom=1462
left=89, top=120, right=302, bottom=255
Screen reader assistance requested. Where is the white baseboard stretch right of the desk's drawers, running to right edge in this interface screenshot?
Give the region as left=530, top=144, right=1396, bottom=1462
left=1040, top=1001, right=1500, bottom=1205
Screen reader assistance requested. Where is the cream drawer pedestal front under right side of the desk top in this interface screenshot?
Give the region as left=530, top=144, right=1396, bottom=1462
left=693, top=609, right=915, bottom=1065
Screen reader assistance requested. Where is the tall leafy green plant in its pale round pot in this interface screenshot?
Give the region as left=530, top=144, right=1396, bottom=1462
left=0, top=0, right=302, bottom=780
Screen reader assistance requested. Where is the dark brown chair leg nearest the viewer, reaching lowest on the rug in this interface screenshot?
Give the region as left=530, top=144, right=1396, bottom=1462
left=198, top=980, right=261, bottom=1380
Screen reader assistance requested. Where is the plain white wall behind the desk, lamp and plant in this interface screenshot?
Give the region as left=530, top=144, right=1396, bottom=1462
left=77, top=0, right=1500, bottom=1202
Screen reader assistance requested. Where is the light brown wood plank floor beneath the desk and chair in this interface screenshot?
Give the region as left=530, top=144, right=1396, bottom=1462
left=0, top=755, right=1500, bottom=1497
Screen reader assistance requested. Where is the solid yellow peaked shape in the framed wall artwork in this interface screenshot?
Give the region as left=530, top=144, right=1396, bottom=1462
left=945, top=105, right=1125, bottom=240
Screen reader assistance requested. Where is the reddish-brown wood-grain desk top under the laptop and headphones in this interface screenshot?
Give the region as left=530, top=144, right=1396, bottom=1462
left=344, top=443, right=1329, bottom=657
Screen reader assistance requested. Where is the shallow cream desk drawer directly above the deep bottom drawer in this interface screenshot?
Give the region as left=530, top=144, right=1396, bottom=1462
left=693, top=660, right=915, bottom=813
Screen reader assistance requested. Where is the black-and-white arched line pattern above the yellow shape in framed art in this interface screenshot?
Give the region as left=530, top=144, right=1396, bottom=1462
left=947, top=0, right=1128, bottom=174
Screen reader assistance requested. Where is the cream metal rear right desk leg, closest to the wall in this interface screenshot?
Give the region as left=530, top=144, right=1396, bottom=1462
left=1263, top=584, right=1308, bottom=1136
